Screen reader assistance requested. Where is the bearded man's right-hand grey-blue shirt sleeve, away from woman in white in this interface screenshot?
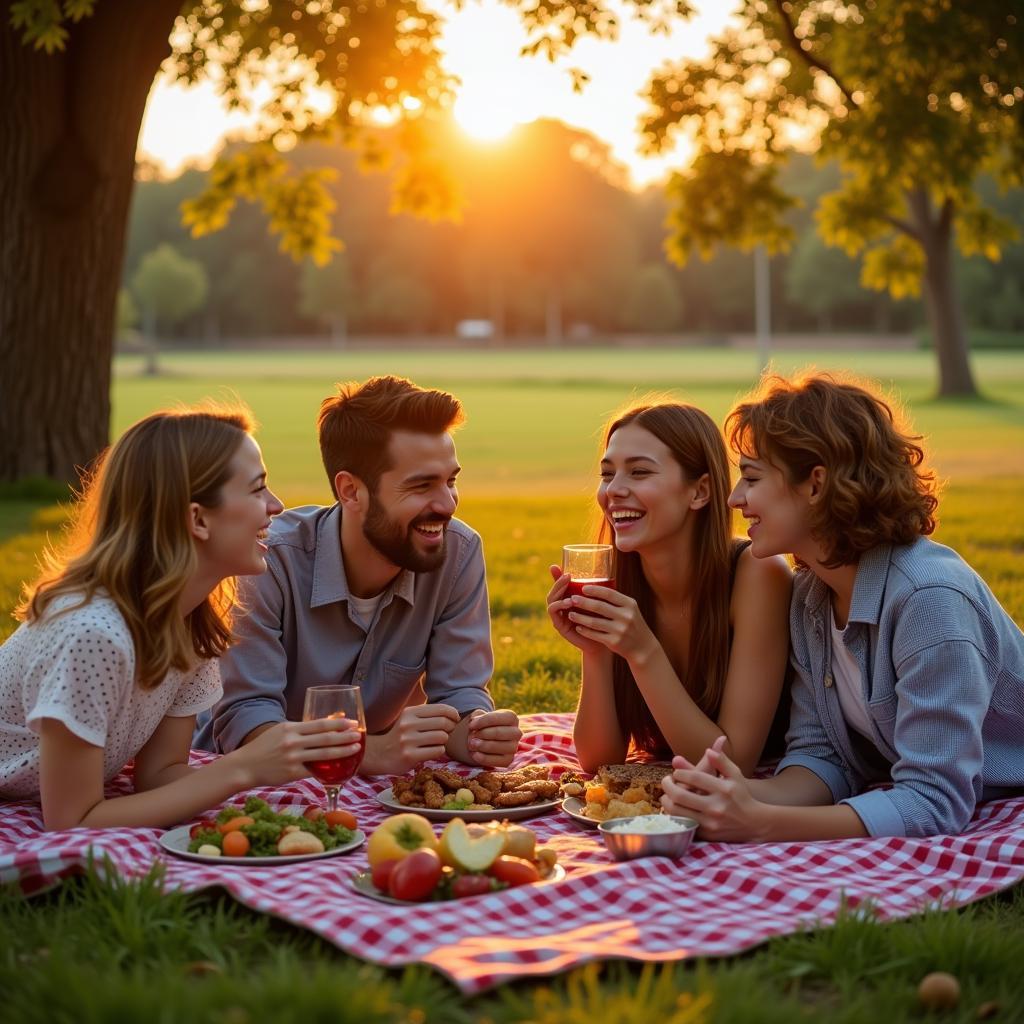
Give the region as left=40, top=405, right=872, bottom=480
left=424, top=534, right=495, bottom=715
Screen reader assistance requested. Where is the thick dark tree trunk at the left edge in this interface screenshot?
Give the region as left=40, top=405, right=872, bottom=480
left=0, top=0, right=181, bottom=481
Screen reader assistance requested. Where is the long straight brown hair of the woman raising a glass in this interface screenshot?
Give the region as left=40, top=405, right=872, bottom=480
left=599, top=401, right=732, bottom=755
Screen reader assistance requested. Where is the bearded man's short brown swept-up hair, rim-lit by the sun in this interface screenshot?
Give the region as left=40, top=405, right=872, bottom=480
left=316, top=377, right=465, bottom=494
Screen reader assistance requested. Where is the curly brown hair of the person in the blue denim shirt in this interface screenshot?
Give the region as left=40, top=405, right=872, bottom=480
left=725, top=372, right=939, bottom=568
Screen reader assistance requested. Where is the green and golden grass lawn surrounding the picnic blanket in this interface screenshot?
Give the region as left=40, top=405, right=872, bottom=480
left=0, top=350, right=1024, bottom=1024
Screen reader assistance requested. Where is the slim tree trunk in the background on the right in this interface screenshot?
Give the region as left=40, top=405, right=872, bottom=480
left=909, top=188, right=978, bottom=398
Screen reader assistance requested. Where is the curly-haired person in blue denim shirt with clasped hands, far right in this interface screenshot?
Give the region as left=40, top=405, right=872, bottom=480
left=664, top=374, right=1024, bottom=842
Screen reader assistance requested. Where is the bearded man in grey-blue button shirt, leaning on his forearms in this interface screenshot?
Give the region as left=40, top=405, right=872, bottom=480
left=195, top=377, right=521, bottom=774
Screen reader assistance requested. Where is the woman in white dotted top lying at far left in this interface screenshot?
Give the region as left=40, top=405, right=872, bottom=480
left=0, top=407, right=358, bottom=829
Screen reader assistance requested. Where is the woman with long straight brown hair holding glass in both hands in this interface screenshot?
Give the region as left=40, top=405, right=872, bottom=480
left=548, top=402, right=791, bottom=773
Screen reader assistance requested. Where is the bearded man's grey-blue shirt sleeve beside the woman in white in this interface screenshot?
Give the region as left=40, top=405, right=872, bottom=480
left=204, top=561, right=288, bottom=754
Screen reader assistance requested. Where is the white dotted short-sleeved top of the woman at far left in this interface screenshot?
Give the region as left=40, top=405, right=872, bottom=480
left=0, top=594, right=221, bottom=800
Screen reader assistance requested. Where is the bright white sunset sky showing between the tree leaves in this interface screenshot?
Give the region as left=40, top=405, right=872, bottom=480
left=139, top=0, right=734, bottom=185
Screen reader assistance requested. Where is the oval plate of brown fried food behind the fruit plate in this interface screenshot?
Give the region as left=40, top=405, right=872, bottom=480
left=377, top=765, right=560, bottom=821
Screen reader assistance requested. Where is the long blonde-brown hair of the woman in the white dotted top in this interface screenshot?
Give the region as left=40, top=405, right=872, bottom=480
left=16, top=404, right=253, bottom=689
